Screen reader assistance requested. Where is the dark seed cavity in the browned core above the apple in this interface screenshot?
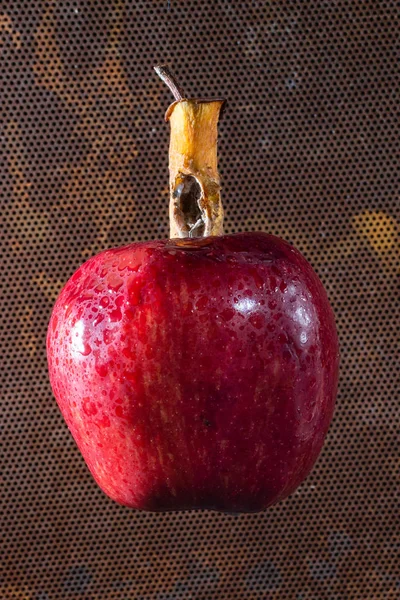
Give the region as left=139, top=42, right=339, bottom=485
left=173, top=175, right=205, bottom=237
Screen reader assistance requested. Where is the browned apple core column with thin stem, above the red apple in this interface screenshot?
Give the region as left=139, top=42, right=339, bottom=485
left=155, top=65, right=224, bottom=238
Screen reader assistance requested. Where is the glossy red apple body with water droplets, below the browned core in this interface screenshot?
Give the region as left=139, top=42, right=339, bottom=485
left=47, top=233, right=339, bottom=512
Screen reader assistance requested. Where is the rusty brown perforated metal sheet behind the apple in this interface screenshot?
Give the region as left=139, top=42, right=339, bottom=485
left=0, top=0, right=400, bottom=600
